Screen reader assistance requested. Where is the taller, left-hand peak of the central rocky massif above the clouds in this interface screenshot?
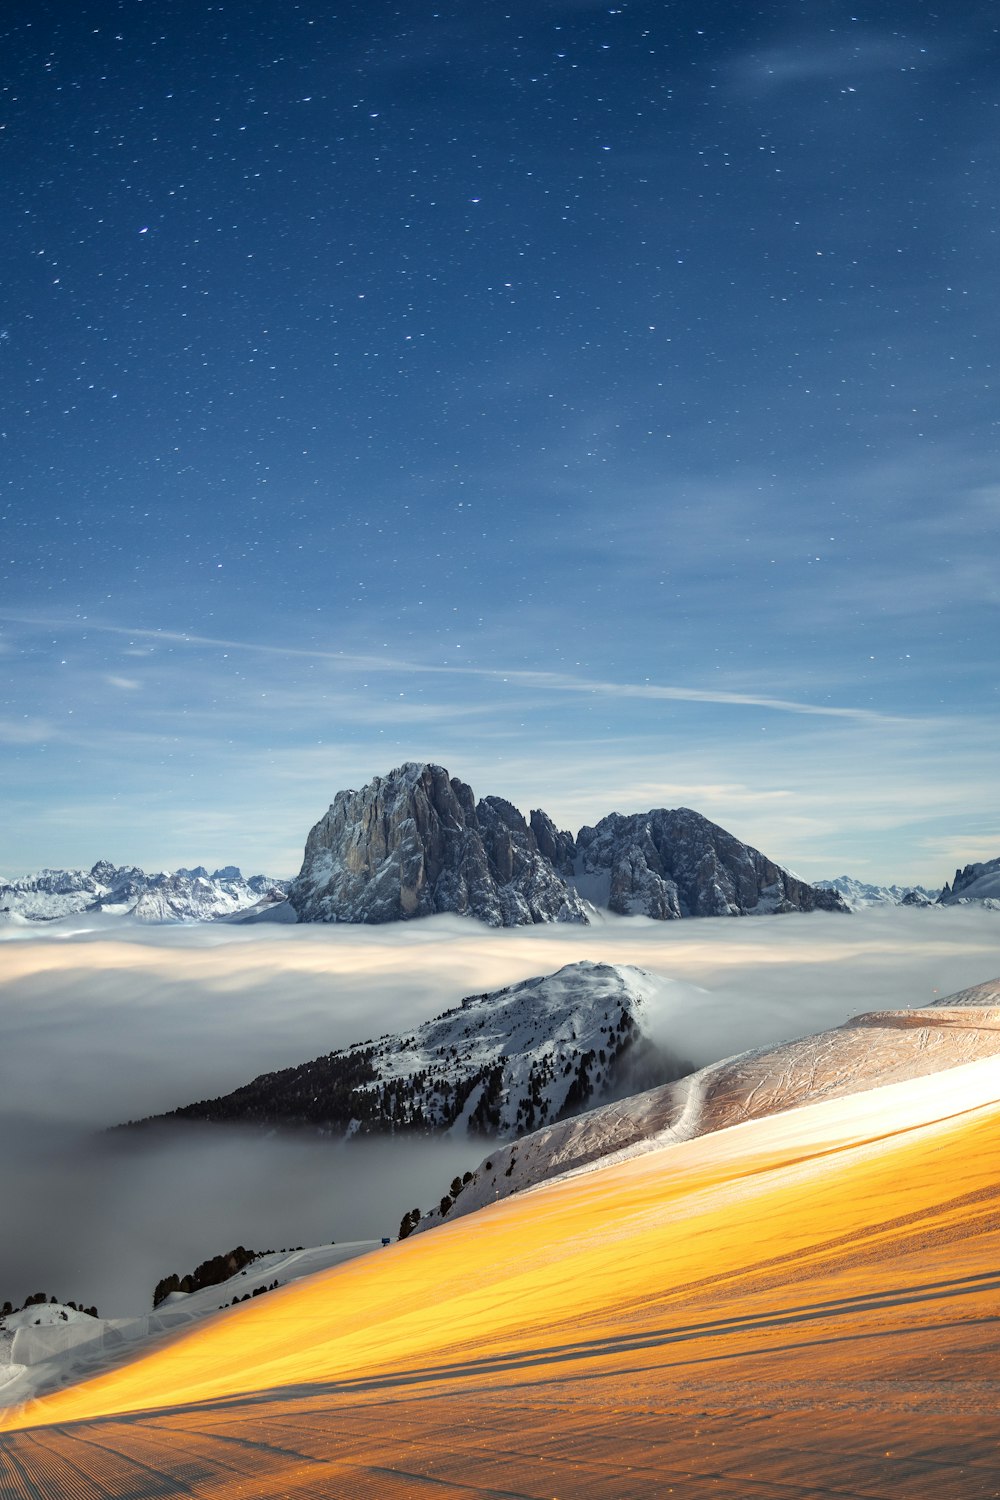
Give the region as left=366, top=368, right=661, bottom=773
left=289, top=762, right=586, bottom=927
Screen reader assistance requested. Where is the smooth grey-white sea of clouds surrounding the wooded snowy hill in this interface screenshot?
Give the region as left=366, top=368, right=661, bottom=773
left=0, top=908, right=1000, bottom=1316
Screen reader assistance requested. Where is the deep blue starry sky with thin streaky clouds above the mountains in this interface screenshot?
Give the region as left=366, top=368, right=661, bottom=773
left=0, top=0, right=1000, bottom=884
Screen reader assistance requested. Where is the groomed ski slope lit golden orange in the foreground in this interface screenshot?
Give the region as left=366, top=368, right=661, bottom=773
left=0, top=1059, right=1000, bottom=1500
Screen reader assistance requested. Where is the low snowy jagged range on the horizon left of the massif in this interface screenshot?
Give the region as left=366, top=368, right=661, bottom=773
left=0, top=860, right=288, bottom=923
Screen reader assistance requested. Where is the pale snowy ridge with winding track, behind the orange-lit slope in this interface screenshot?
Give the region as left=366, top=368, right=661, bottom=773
left=413, top=980, right=1000, bottom=1233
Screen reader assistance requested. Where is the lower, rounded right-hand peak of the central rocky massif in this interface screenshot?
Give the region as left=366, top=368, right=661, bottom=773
left=576, top=807, right=847, bottom=921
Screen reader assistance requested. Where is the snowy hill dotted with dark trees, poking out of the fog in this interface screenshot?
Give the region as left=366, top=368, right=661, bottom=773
left=138, top=963, right=690, bottom=1139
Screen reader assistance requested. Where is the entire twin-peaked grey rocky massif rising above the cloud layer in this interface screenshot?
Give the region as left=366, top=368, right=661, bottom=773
left=289, top=762, right=847, bottom=927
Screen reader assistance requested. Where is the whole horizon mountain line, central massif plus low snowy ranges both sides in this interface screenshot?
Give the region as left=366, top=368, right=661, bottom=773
left=0, top=761, right=1000, bottom=927
